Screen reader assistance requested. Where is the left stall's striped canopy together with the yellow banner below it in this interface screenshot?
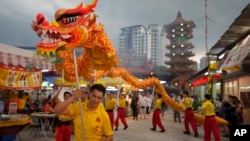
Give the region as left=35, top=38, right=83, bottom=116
left=0, top=43, right=54, bottom=90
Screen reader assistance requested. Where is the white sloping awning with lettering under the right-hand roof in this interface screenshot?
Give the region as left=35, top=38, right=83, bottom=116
left=221, top=35, right=250, bottom=71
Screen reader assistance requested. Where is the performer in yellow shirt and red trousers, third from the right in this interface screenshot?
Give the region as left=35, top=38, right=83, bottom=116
left=150, top=94, right=165, bottom=132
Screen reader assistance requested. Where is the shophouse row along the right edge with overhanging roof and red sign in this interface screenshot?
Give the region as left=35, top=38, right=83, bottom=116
left=188, top=4, right=250, bottom=124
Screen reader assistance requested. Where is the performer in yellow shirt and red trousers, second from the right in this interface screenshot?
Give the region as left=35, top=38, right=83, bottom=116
left=182, top=91, right=199, bottom=137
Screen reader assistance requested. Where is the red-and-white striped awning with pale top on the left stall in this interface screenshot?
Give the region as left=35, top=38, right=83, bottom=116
left=0, top=43, right=54, bottom=70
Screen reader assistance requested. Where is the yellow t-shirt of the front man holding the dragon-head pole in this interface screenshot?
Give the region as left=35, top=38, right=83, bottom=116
left=68, top=102, right=113, bottom=141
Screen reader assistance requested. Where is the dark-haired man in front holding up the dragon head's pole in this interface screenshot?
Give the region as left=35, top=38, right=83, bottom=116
left=55, top=84, right=113, bottom=141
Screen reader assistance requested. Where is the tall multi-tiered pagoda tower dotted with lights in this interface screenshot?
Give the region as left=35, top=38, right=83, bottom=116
left=164, top=11, right=197, bottom=76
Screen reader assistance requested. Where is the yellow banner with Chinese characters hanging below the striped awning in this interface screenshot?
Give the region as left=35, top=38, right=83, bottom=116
left=0, top=67, right=42, bottom=90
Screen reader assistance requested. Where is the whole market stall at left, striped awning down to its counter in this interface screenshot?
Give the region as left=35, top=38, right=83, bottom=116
left=0, top=43, right=54, bottom=141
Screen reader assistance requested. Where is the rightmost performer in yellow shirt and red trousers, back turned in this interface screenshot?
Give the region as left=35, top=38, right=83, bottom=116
left=197, top=94, right=220, bottom=141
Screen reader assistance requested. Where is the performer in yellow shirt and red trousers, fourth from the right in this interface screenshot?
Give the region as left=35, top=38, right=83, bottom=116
left=115, top=94, right=128, bottom=131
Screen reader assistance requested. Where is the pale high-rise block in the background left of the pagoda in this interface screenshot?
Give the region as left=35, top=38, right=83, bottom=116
left=118, top=24, right=164, bottom=66
